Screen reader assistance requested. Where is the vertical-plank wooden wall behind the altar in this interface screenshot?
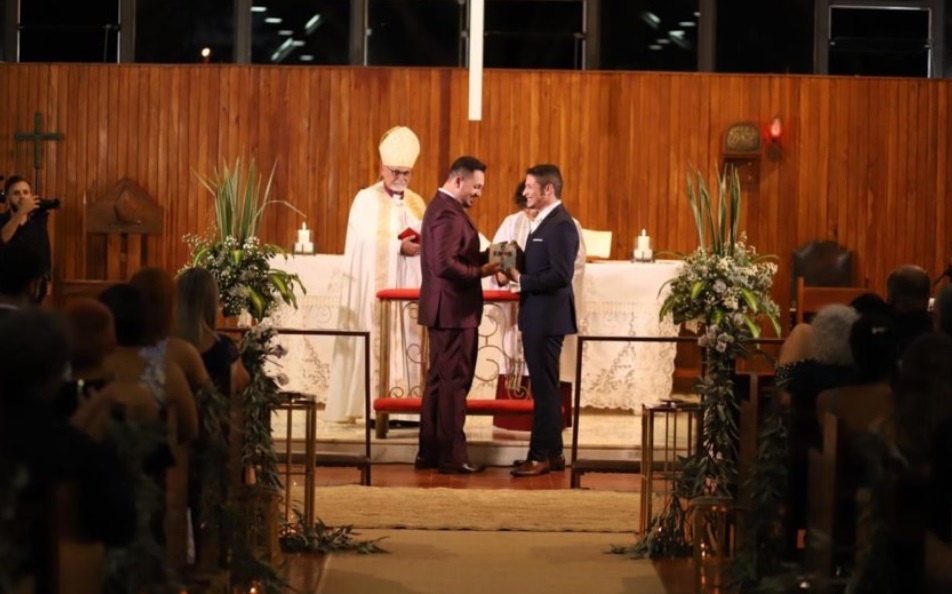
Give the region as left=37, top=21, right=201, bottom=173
left=0, top=64, right=952, bottom=320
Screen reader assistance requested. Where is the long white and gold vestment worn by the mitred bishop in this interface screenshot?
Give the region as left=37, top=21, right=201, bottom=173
left=324, top=181, right=426, bottom=422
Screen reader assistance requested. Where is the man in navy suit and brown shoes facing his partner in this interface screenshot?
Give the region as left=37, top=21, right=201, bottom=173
left=508, top=165, right=579, bottom=477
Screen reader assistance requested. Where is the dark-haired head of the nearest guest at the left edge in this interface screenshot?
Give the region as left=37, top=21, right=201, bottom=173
left=0, top=308, right=69, bottom=404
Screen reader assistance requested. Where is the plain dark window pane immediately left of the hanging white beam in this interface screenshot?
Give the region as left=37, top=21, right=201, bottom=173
left=367, top=0, right=466, bottom=66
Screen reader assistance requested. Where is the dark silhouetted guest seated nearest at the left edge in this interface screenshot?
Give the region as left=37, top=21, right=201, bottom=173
left=0, top=310, right=136, bottom=591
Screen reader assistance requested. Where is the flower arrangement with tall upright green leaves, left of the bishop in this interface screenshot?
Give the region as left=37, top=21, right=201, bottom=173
left=184, top=159, right=306, bottom=321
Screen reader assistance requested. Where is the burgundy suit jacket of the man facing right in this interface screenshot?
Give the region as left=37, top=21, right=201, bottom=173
left=419, top=192, right=486, bottom=328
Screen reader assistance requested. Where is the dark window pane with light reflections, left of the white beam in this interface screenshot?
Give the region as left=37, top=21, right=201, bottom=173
left=251, top=0, right=350, bottom=65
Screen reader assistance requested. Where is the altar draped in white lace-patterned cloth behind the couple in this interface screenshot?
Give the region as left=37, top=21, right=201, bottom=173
left=267, top=254, right=680, bottom=411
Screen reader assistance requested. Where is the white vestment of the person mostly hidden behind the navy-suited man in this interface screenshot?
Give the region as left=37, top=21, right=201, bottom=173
left=483, top=210, right=585, bottom=382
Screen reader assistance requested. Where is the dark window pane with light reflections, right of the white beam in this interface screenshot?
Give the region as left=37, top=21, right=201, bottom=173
left=600, top=0, right=698, bottom=71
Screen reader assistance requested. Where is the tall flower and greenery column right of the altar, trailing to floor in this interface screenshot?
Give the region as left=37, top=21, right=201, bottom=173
left=612, top=168, right=780, bottom=557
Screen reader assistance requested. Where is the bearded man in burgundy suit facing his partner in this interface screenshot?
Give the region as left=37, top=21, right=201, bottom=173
left=415, top=157, right=499, bottom=474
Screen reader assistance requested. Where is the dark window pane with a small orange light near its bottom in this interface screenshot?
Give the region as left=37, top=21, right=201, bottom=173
left=136, top=0, right=235, bottom=64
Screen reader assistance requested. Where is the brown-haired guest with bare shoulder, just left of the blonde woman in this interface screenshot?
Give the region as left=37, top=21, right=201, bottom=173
left=129, top=268, right=211, bottom=392
